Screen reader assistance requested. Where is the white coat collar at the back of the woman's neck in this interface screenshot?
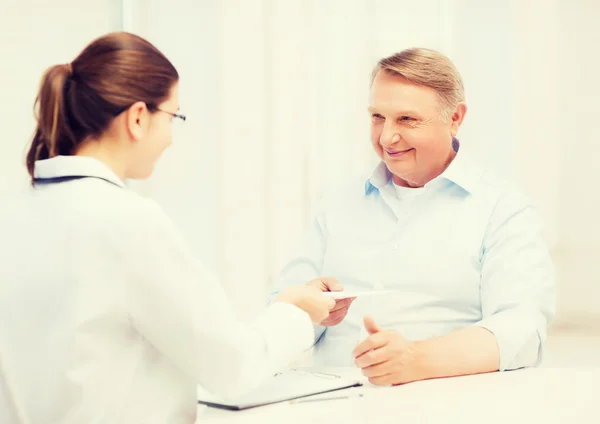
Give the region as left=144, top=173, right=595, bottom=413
left=33, top=156, right=125, bottom=188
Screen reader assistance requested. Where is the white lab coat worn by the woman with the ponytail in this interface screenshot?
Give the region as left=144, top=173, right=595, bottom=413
left=0, top=157, right=313, bottom=424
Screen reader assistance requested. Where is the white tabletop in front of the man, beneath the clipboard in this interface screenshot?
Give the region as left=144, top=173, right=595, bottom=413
left=197, top=368, right=600, bottom=424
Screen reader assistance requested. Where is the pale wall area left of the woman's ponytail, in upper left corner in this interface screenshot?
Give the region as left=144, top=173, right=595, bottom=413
left=0, top=0, right=121, bottom=198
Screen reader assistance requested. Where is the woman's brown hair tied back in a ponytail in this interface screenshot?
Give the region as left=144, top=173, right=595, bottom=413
left=26, top=32, right=179, bottom=181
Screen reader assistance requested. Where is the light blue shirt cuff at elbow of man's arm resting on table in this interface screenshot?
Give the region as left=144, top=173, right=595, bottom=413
left=474, top=311, right=545, bottom=371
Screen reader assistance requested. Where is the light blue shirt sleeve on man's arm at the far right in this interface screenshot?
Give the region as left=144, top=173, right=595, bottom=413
left=476, top=189, right=556, bottom=371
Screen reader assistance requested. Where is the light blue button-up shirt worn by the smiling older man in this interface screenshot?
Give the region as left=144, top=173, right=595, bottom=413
left=275, top=149, right=555, bottom=370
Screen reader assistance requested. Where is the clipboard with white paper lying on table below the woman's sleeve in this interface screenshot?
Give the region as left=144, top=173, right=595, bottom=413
left=198, top=369, right=362, bottom=411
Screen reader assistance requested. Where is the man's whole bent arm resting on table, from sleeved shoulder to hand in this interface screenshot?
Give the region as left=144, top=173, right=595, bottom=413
left=354, top=192, right=555, bottom=385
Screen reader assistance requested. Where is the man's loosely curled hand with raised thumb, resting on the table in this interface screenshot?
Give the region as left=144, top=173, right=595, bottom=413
left=352, top=316, right=423, bottom=386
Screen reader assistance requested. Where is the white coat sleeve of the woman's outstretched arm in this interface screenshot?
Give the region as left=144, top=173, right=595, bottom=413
left=124, top=203, right=313, bottom=398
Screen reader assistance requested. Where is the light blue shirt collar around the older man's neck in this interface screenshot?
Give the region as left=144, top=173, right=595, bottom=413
left=365, top=142, right=481, bottom=195
